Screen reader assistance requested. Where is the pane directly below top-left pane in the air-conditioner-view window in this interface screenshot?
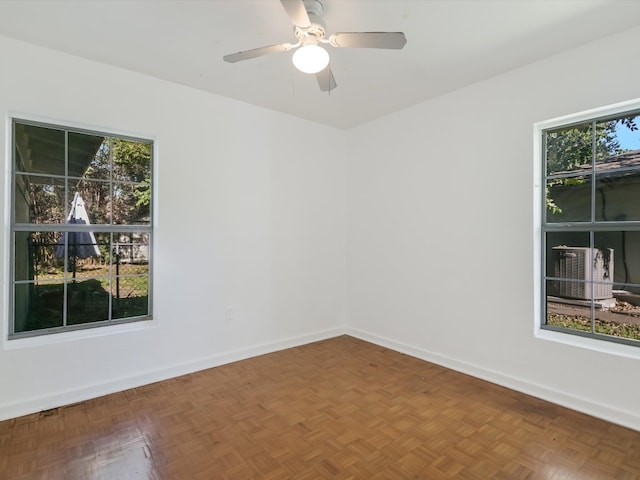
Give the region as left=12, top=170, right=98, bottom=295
left=546, top=175, right=591, bottom=223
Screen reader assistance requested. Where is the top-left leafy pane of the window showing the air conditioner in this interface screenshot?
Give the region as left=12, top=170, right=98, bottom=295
left=545, top=122, right=593, bottom=175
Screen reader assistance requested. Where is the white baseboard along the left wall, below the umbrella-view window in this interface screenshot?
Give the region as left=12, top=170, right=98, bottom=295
left=0, top=327, right=345, bottom=421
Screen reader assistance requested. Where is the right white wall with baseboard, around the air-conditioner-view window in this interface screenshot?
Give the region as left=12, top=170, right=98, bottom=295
left=347, top=25, right=640, bottom=429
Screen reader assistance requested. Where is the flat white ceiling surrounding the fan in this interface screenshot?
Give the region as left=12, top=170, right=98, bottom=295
left=0, top=0, right=640, bottom=128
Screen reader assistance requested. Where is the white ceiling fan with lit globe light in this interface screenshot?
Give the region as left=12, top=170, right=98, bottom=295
left=222, top=0, right=407, bottom=92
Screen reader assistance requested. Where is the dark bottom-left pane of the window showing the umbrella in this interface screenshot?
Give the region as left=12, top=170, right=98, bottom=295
left=14, top=282, right=64, bottom=333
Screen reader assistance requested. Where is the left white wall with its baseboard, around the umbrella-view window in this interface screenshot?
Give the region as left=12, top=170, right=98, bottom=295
left=0, top=37, right=346, bottom=418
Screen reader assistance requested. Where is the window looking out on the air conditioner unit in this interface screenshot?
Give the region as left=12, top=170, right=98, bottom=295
left=540, top=106, right=640, bottom=346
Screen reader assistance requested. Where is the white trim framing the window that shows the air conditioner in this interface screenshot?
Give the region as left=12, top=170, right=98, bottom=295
left=533, top=98, right=640, bottom=359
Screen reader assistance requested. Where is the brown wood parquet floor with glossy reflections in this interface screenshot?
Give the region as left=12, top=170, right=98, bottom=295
left=0, top=336, right=640, bottom=480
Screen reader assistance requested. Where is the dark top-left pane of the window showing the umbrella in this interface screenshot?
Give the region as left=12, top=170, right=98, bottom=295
left=14, top=123, right=65, bottom=176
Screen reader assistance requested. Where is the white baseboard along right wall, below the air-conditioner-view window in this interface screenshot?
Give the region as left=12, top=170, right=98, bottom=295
left=346, top=328, right=640, bottom=431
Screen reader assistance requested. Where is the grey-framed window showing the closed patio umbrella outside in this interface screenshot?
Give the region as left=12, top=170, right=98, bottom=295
left=9, top=119, right=153, bottom=338
